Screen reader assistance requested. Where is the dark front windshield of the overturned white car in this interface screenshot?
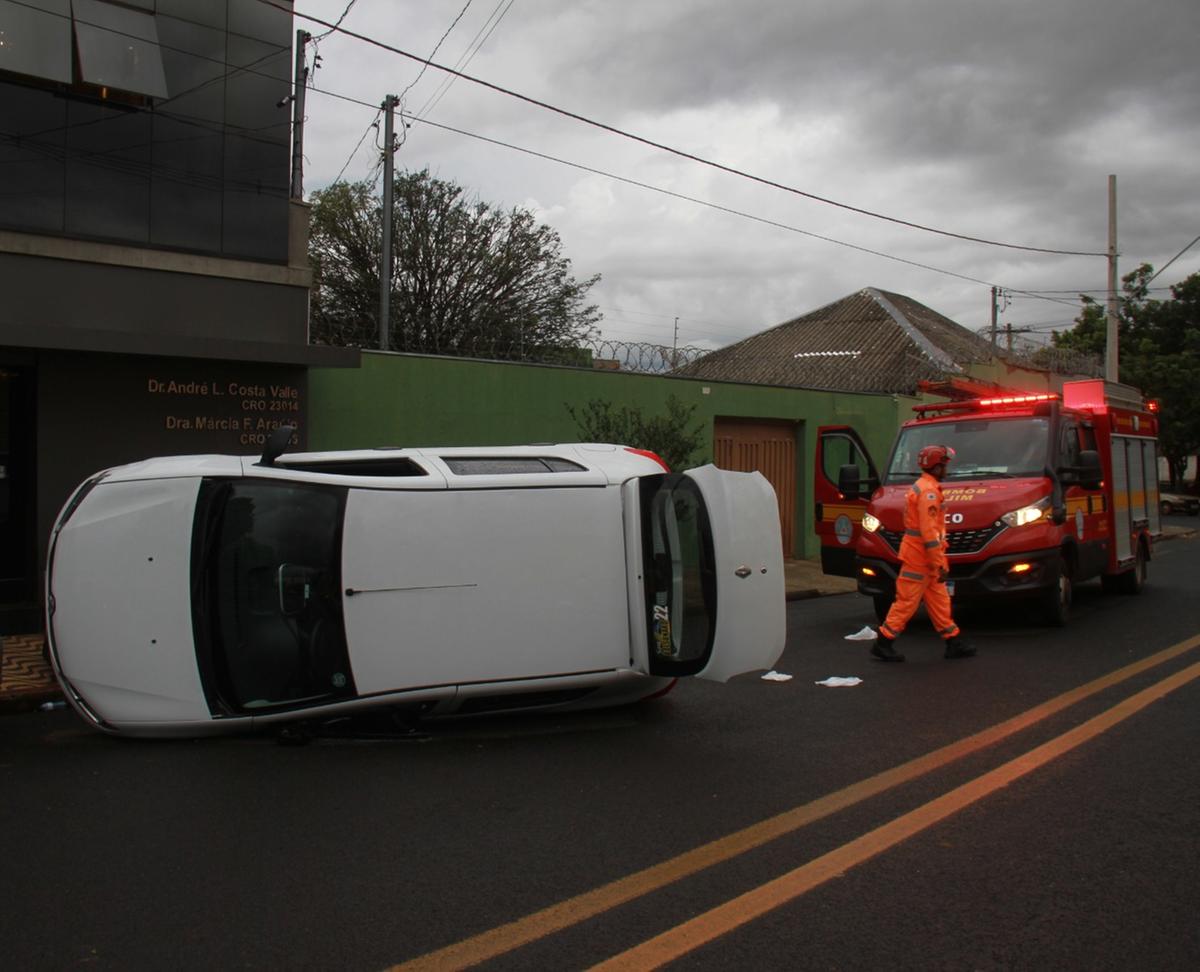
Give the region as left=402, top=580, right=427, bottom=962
left=193, top=480, right=354, bottom=712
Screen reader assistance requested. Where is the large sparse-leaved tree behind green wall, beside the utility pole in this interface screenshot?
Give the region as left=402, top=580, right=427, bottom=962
left=308, top=169, right=600, bottom=360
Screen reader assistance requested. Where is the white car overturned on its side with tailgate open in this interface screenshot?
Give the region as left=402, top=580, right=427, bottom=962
left=47, top=434, right=785, bottom=736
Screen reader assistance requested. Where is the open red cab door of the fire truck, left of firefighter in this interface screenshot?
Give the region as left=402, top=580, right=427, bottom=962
left=812, top=425, right=880, bottom=577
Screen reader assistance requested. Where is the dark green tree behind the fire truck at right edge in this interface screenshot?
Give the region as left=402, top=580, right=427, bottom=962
left=1052, top=263, right=1200, bottom=486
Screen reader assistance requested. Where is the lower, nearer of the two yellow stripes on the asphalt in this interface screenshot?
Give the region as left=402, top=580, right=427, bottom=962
left=593, top=662, right=1200, bottom=972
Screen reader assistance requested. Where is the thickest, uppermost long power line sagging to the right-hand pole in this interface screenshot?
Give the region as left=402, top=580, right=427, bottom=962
left=270, top=0, right=1108, bottom=257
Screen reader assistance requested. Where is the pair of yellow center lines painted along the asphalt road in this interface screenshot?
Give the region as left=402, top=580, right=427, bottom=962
left=395, top=636, right=1200, bottom=971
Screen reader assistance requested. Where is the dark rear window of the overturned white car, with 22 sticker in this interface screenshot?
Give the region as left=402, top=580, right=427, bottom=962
left=641, top=475, right=716, bottom=674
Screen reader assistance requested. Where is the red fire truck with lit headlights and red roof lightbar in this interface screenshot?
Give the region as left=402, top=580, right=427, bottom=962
left=816, top=379, right=1160, bottom=625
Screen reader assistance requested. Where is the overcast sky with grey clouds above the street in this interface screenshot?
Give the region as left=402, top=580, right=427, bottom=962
left=288, top=0, right=1200, bottom=347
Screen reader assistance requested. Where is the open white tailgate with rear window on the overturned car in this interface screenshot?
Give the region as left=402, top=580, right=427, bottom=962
left=635, top=466, right=785, bottom=682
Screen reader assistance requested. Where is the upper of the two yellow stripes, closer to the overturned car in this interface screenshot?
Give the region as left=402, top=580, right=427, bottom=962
left=394, top=636, right=1200, bottom=972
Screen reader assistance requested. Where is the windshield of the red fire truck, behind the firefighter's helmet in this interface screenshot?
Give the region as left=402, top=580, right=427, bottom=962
left=883, top=415, right=1050, bottom=486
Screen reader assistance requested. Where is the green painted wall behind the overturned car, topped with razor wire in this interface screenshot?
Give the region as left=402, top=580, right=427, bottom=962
left=308, top=352, right=916, bottom=557
